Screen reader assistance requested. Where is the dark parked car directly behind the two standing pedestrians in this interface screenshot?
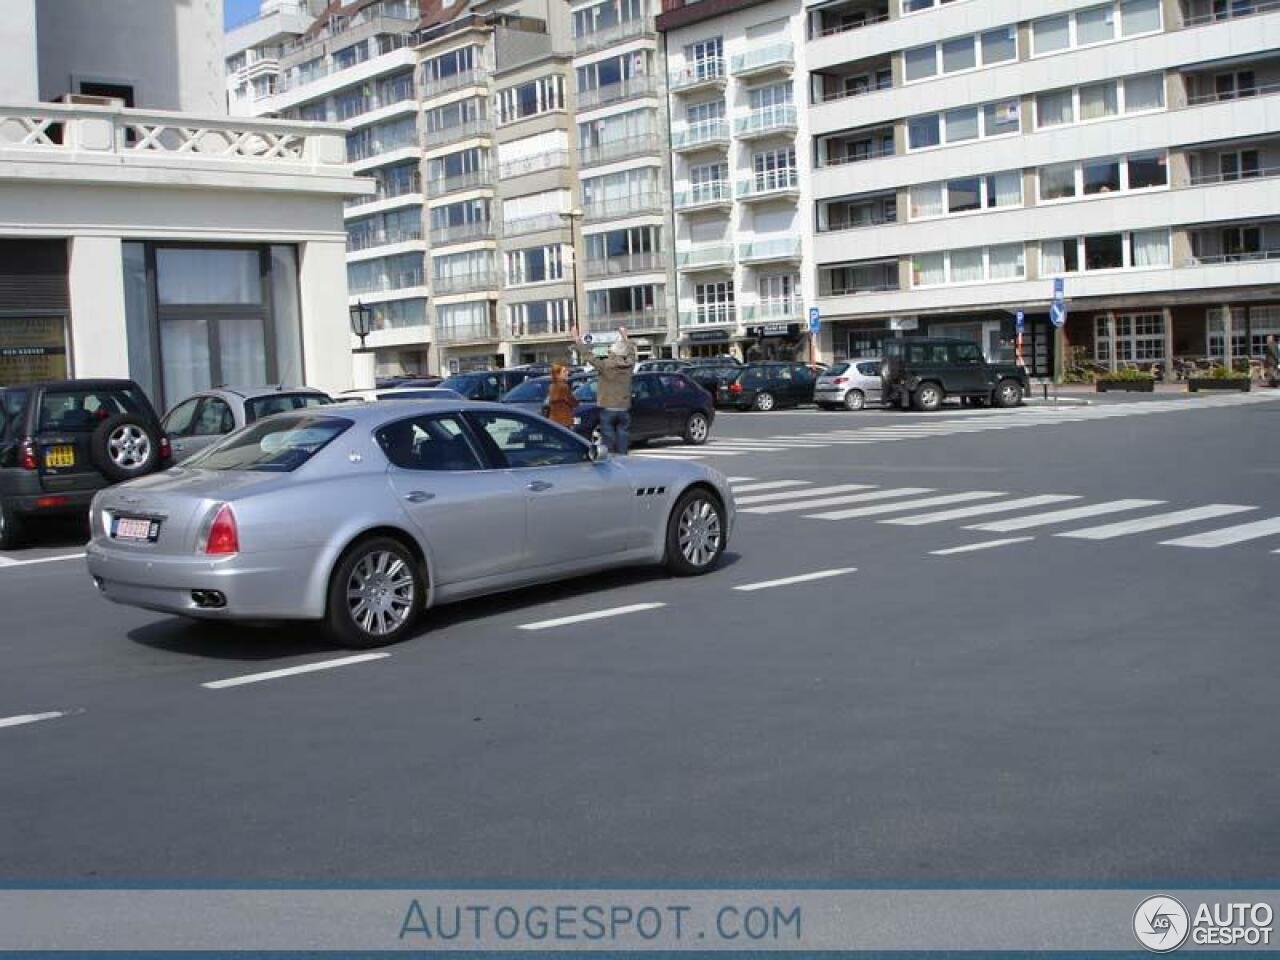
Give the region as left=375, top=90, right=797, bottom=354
left=571, top=374, right=716, bottom=445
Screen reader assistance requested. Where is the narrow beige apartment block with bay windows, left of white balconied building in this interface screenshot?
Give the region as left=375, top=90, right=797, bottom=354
left=572, top=0, right=678, bottom=357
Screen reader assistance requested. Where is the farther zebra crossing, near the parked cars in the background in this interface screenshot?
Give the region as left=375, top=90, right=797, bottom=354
left=631, top=392, right=1280, bottom=463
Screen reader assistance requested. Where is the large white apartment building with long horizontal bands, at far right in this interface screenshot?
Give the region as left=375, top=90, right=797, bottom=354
left=808, top=0, right=1280, bottom=375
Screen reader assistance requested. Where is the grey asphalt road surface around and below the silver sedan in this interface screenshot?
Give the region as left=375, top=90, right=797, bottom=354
left=0, top=398, right=1280, bottom=884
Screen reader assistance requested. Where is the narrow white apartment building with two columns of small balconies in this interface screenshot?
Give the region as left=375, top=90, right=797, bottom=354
left=658, top=0, right=814, bottom=360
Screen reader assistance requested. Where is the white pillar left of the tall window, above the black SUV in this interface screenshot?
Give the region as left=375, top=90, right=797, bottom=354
left=67, top=237, right=129, bottom=378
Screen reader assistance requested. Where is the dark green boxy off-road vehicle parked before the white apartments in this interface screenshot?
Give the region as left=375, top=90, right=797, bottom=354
left=881, top=337, right=1029, bottom=411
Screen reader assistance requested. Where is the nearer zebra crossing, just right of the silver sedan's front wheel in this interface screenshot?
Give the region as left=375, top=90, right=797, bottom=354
left=730, top=476, right=1280, bottom=556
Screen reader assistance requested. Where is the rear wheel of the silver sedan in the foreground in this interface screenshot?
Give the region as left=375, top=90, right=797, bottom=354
left=324, top=536, right=424, bottom=650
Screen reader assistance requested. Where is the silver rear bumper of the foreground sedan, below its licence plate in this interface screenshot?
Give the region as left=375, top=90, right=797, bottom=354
left=86, top=539, right=325, bottom=620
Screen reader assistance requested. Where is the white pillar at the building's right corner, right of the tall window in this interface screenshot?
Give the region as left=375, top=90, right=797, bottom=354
left=298, top=239, right=358, bottom=393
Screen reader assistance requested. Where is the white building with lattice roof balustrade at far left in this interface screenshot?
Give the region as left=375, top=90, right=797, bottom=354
left=0, top=0, right=366, bottom=408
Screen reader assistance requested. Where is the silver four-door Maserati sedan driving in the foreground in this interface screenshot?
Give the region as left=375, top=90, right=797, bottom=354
left=87, top=401, right=733, bottom=648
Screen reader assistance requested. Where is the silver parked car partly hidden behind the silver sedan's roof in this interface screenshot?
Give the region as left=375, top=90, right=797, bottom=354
left=161, top=387, right=333, bottom=463
